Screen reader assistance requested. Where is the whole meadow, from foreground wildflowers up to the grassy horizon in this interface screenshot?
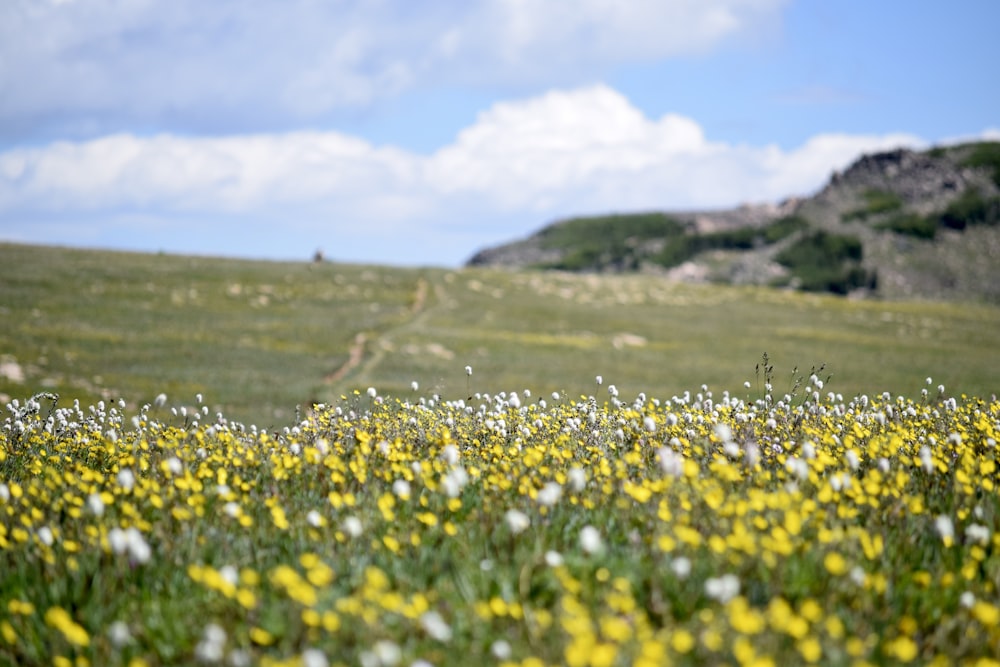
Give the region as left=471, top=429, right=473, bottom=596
left=0, top=246, right=1000, bottom=667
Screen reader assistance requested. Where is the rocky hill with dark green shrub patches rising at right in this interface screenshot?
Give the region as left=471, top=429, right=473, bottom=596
left=468, top=142, right=1000, bottom=303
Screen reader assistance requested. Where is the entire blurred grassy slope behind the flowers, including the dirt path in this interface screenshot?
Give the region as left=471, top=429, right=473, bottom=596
left=0, top=244, right=1000, bottom=426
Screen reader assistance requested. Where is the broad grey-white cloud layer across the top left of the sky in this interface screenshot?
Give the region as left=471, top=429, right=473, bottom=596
left=0, top=0, right=787, bottom=137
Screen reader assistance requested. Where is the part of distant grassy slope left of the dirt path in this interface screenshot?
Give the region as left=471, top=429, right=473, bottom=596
left=0, top=245, right=419, bottom=425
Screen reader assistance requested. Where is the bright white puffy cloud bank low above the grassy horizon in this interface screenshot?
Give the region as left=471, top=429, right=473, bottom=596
left=0, top=85, right=936, bottom=264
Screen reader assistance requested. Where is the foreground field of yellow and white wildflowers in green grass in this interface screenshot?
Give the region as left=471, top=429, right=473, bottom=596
left=0, top=374, right=1000, bottom=667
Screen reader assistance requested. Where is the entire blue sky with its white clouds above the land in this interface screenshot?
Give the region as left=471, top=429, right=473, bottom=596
left=0, top=0, right=1000, bottom=267
